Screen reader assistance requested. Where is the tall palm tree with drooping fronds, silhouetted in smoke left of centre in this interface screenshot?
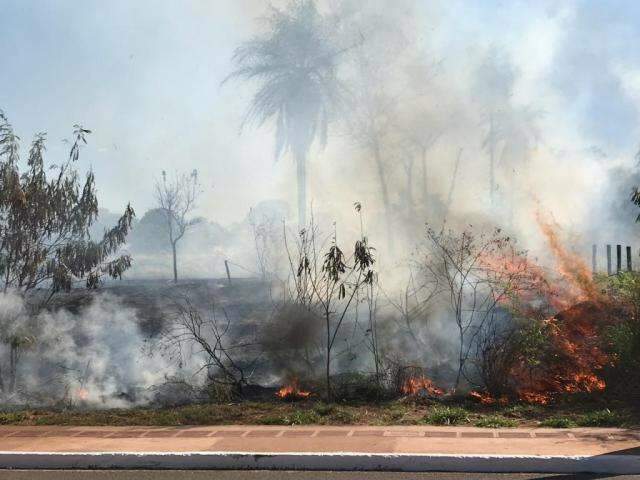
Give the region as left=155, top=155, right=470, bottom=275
left=225, top=0, right=341, bottom=227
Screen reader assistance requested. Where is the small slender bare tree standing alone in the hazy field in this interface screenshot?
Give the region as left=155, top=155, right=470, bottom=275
left=156, top=170, right=200, bottom=283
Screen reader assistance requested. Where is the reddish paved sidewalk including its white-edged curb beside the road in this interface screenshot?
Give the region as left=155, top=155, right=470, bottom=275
left=0, top=426, right=640, bottom=473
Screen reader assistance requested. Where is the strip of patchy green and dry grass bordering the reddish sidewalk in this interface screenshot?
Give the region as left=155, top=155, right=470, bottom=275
left=0, top=399, right=640, bottom=428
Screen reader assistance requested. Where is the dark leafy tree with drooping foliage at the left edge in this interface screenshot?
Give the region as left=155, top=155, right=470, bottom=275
left=0, top=111, right=135, bottom=299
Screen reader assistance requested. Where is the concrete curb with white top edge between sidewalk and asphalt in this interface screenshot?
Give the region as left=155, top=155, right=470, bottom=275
left=0, top=452, right=640, bottom=474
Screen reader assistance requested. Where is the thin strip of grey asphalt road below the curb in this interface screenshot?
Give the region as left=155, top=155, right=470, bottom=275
left=0, top=470, right=640, bottom=480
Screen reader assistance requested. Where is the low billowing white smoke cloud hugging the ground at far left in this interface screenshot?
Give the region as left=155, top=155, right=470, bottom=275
left=0, top=293, right=177, bottom=408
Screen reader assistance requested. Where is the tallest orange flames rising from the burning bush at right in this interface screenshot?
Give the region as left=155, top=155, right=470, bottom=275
left=498, top=213, right=615, bottom=405
